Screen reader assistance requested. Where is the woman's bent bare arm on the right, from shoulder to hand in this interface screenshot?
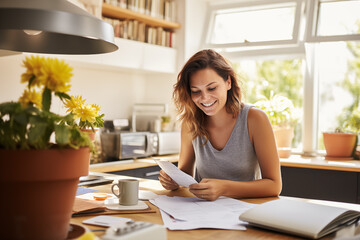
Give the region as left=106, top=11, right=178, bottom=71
left=190, top=108, right=282, bottom=200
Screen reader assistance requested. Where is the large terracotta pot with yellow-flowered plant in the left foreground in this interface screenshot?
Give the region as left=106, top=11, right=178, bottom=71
left=0, top=56, right=93, bottom=239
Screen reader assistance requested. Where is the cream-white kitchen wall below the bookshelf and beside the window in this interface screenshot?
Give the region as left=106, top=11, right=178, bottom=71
left=0, top=0, right=207, bottom=122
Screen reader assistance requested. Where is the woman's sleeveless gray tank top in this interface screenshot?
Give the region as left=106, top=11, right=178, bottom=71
left=192, top=104, right=260, bottom=182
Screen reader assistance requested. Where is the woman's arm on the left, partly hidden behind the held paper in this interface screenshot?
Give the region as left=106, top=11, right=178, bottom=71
left=159, top=125, right=195, bottom=190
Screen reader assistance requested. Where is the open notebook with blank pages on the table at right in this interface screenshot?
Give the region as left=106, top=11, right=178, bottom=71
left=240, top=199, right=360, bottom=239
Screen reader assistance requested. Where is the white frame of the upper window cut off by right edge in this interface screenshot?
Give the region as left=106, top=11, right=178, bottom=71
left=305, top=0, right=360, bottom=43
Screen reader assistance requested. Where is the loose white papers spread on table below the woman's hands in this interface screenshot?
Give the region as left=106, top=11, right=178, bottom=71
left=150, top=196, right=256, bottom=230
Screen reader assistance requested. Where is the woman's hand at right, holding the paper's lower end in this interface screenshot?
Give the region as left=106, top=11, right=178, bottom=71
left=189, top=178, right=225, bottom=201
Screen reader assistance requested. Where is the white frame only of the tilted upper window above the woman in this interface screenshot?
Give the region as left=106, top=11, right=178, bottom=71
left=203, top=0, right=304, bottom=51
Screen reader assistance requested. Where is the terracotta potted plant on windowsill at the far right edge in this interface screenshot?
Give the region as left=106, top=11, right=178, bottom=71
left=323, top=107, right=360, bottom=160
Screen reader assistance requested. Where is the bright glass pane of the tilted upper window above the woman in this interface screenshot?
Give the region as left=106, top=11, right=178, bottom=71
left=210, top=6, right=295, bottom=44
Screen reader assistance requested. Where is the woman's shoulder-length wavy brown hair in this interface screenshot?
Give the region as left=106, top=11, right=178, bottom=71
left=173, top=49, right=242, bottom=140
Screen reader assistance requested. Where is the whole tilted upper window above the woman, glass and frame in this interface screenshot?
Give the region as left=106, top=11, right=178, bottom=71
left=206, top=0, right=302, bottom=48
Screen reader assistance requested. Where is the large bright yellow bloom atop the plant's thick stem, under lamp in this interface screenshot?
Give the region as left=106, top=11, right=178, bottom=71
left=38, top=58, right=73, bottom=93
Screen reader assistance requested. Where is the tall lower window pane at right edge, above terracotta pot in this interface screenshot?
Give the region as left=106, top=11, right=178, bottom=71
left=317, top=42, right=360, bottom=150
